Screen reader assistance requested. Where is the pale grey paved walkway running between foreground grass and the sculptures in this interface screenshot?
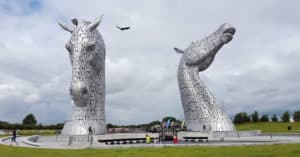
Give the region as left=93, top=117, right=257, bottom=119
left=0, top=135, right=300, bottom=149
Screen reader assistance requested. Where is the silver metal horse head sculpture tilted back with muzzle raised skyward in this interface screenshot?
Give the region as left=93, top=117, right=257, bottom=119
left=175, top=24, right=235, bottom=131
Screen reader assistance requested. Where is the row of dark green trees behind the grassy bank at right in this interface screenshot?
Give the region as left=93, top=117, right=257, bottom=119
left=233, top=110, right=300, bottom=124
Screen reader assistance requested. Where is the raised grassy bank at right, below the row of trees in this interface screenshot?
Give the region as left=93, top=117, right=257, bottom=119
left=235, top=122, right=300, bottom=133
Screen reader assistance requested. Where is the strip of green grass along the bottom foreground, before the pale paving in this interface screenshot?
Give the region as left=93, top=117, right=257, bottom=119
left=0, top=144, right=300, bottom=157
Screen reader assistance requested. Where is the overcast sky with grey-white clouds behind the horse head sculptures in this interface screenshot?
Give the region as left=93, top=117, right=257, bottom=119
left=0, top=0, right=300, bottom=124
